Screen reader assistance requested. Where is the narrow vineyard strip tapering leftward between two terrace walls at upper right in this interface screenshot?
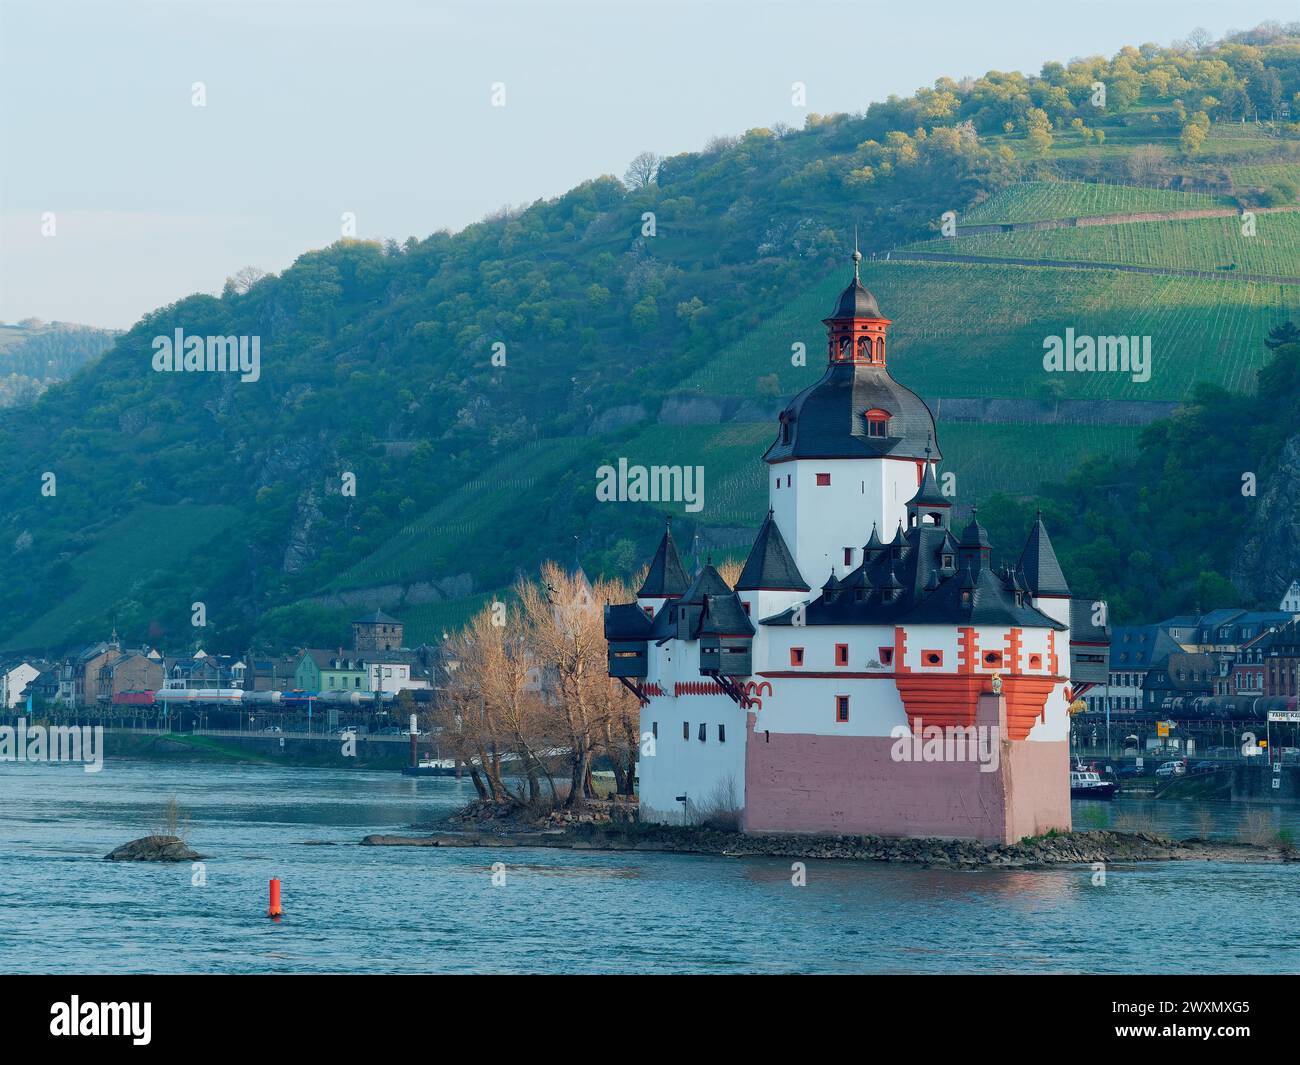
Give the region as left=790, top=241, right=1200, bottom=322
left=914, top=212, right=1300, bottom=280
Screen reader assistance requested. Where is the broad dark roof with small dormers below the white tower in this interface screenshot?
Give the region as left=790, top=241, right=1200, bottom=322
left=762, top=525, right=1065, bottom=629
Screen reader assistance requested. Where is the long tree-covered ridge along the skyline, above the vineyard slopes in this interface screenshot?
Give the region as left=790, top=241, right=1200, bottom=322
left=0, top=27, right=1300, bottom=650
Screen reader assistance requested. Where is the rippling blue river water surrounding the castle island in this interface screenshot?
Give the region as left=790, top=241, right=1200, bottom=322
left=0, top=761, right=1300, bottom=973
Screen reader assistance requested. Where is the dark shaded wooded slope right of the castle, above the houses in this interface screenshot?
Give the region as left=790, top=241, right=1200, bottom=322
left=980, top=322, right=1300, bottom=620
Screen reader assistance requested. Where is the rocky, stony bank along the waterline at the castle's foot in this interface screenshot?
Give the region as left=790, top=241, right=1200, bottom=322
left=361, top=822, right=1300, bottom=869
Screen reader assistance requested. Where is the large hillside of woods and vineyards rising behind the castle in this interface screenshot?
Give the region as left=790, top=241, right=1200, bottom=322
left=0, top=27, right=1300, bottom=650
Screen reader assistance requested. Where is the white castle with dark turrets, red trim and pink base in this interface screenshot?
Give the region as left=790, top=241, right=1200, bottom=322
left=605, top=252, right=1105, bottom=841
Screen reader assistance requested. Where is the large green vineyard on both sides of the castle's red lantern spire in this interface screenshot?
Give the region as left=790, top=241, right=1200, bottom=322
left=683, top=258, right=1300, bottom=404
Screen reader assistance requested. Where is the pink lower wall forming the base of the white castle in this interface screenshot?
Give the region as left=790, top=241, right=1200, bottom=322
left=742, top=694, right=1070, bottom=843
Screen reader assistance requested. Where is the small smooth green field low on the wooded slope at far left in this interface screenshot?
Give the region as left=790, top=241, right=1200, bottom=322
left=10, top=505, right=239, bottom=648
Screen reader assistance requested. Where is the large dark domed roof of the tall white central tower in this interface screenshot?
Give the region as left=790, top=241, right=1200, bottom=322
left=763, top=363, right=943, bottom=463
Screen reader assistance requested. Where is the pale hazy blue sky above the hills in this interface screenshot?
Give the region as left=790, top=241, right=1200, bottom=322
left=0, top=0, right=1300, bottom=326
